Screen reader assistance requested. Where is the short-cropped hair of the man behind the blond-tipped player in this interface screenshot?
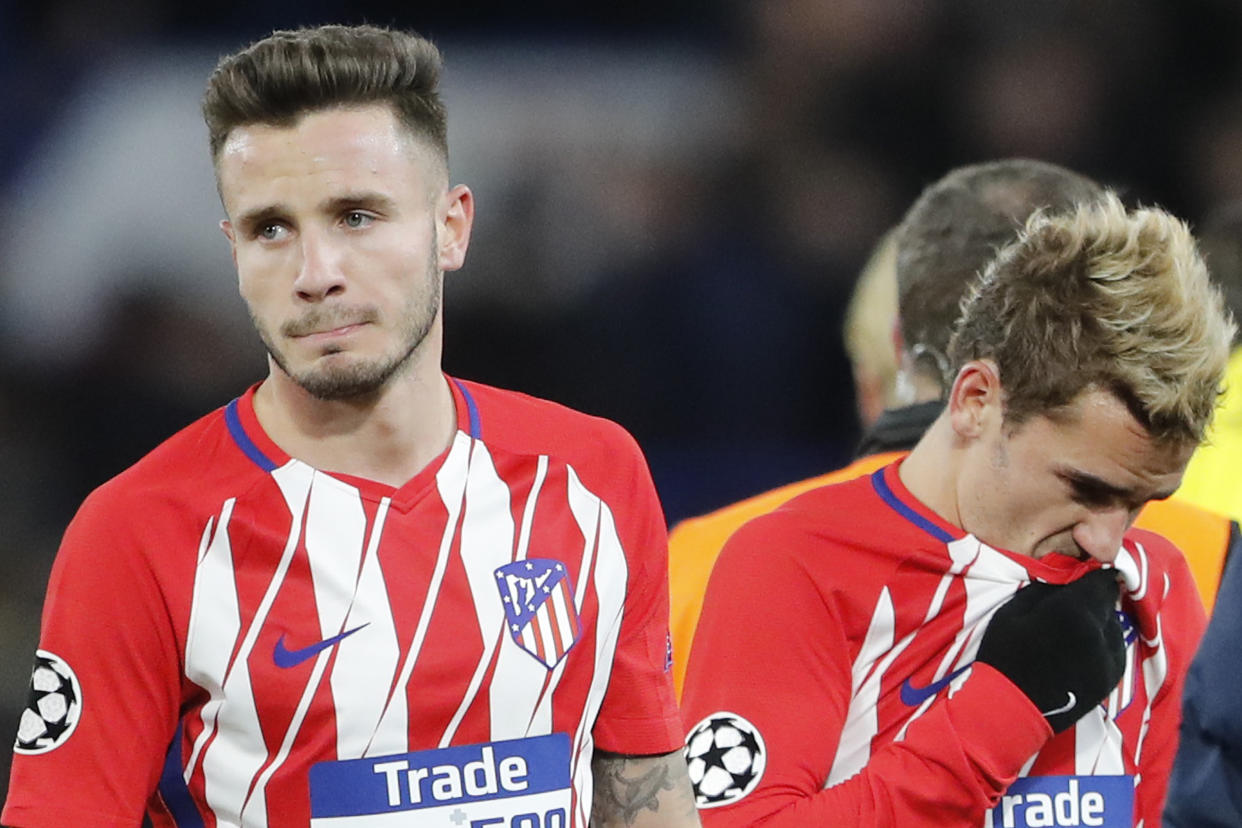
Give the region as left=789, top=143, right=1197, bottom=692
left=897, top=158, right=1104, bottom=389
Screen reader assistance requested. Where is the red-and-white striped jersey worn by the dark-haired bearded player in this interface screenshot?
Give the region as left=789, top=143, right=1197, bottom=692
left=2, top=380, right=682, bottom=828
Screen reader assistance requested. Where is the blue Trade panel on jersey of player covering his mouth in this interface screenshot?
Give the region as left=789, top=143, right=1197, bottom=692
left=984, top=776, right=1134, bottom=828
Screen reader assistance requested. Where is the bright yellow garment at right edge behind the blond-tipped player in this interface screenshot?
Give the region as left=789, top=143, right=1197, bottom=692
left=1175, top=348, right=1242, bottom=520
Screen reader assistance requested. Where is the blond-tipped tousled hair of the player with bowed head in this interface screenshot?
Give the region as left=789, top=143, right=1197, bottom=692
left=949, top=192, right=1235, bottom=443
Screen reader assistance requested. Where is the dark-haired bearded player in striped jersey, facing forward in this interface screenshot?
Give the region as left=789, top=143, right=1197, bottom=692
left=2, top=26, right=698, bottom=828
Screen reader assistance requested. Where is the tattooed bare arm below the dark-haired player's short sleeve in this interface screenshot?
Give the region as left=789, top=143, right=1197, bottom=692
left=591, top=751, right=698, bottom=828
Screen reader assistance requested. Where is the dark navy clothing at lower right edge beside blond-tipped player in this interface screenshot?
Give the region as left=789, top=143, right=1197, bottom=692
left=1165, top=533, right=1242, bottom=828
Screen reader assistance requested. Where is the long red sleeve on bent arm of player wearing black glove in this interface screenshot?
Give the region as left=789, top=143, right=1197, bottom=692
left=683, top=515, right=1052, bottom=828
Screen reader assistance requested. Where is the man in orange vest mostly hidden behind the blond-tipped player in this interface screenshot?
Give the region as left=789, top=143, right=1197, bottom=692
left=668, top=159, right=1240, bottom=698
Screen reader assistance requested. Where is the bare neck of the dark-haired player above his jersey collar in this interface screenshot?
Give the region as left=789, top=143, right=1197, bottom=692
left=255, top=354, right=457, bottom=487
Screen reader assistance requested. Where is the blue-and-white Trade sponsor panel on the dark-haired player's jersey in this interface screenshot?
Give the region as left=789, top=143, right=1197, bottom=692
left=309, top=734, right=570, bottom=828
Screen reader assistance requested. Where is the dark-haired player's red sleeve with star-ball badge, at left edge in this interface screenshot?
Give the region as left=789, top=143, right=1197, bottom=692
left=2, top=492, right=180, bottom=828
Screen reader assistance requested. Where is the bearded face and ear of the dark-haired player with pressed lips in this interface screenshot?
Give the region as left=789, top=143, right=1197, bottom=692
left=217, top=106, right=472, bottom=400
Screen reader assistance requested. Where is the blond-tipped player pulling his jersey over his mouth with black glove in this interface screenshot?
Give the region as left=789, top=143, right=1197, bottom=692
left=683, top=195, right=1233, bottom=828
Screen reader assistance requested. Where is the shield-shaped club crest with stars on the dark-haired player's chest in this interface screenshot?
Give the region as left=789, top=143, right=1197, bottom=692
left=496, top=557, right=581, bottom=670
